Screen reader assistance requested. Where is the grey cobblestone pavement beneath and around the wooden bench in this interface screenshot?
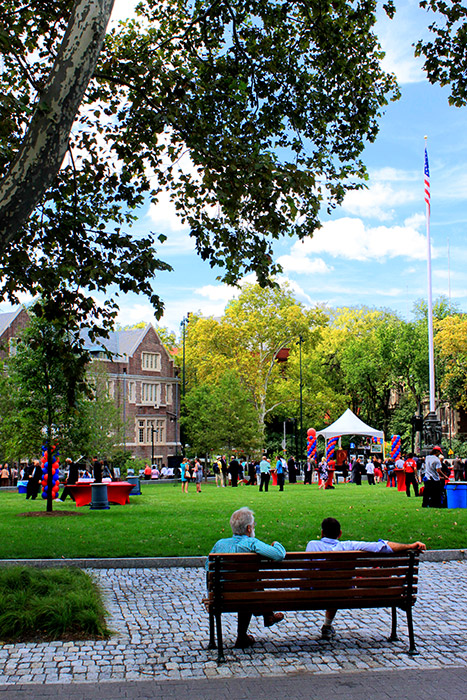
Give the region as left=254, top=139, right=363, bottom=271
left=0, top=561, right=467, bottom=688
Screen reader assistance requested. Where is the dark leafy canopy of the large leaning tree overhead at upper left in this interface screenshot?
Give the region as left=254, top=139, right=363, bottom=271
left=0, top=0, right=396, bottom=330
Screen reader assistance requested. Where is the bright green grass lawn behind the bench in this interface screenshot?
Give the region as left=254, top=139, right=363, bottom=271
left=0, top=482, right=467, bottom=559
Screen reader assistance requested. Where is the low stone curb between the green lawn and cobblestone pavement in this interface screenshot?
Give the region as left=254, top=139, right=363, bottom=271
left=0, top=549, right=467, bottom=569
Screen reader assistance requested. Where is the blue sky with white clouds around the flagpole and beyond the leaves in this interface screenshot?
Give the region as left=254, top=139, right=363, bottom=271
left=3, top=0, right=467, bottom=331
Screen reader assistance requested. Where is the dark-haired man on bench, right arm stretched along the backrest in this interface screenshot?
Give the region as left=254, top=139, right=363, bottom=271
left=306, top=518, right=426, bottom=639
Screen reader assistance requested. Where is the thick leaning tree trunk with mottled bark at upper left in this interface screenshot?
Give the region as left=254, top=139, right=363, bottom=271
left=0, top=0, right=114, bottom=251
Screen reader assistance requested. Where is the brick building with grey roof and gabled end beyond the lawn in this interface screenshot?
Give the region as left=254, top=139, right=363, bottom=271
left=83, top=324, right=180, bottom=465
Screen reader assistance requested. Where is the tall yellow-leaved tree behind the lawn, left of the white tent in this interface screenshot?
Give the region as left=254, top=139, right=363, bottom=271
left=183, top=284, right=325, bottom=438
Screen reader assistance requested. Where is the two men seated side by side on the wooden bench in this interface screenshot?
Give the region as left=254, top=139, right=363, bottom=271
left=206, top=508, right=426, bottom=649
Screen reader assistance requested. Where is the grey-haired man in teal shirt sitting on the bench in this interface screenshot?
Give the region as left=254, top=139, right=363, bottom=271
left=206, top=508, right=285, bottom=649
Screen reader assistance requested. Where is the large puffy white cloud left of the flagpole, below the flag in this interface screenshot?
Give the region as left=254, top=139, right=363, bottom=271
left=292, top=217, right=432, bottom=261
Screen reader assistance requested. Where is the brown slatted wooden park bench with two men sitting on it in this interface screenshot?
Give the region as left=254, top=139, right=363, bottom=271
left=204, top=551, right=418, bottom=662
